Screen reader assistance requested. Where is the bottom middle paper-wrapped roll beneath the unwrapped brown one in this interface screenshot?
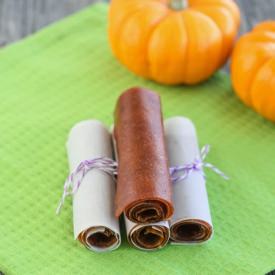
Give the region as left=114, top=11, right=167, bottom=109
left=111, top=127, right=170, bottom=251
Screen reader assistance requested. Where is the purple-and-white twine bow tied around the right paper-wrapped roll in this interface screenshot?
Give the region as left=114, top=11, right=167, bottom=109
left=169, top=145, right=229, bottom=183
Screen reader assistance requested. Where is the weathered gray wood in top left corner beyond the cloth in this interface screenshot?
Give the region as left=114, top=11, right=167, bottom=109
left=0, top=0, right=101, bottom=46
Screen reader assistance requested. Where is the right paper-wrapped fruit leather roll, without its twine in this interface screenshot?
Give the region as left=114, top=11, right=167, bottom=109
left=164, top=117, right=213, bottom=244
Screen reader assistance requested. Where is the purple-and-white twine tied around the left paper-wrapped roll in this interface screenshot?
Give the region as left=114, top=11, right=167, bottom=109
left=56, top=157, right=118, bottom=215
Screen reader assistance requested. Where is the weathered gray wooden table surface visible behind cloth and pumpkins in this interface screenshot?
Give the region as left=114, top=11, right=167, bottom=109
left=0, top=0, right=275, bottom=47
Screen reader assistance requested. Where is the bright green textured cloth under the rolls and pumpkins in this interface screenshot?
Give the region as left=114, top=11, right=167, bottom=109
left=0, top=4, right=275, bottom=275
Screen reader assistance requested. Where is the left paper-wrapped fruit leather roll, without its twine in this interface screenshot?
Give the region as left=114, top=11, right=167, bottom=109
left=67, top=120, right=121, bottom=252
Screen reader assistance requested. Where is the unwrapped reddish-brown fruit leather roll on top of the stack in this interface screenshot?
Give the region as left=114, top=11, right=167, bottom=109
left=114, top=88, right=173, bottom=223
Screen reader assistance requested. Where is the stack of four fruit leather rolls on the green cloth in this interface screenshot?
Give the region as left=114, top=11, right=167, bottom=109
left=61, top=88, right=213, bottom=252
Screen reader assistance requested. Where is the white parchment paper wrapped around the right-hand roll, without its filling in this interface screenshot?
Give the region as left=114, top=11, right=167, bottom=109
left=164, top=117, right=213, bottom=244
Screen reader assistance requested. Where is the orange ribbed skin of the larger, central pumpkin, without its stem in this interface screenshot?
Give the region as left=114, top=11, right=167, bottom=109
left=109, top=0, right=240, bottom=84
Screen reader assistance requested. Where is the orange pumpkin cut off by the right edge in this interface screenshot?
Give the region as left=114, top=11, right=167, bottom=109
left=231, top=21, right=275, bottom=121
